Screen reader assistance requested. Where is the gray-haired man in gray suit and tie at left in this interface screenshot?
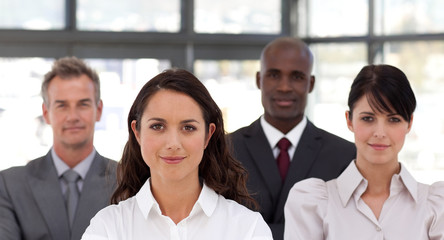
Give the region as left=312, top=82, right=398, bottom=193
left=0, top=57, right=117, bottom=240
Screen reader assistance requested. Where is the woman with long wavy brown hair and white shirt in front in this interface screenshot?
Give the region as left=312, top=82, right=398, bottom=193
left=82, top=70, right=272, bottom=240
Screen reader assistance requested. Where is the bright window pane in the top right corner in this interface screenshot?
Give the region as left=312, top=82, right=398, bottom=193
left=375, top=0, right=444, bottom=35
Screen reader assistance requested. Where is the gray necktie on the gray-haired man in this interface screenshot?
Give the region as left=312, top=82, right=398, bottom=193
left=62, top=169, right=80, bottom=226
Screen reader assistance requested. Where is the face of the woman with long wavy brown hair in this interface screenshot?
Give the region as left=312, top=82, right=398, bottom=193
left=131, top=90, right=216, bottom=185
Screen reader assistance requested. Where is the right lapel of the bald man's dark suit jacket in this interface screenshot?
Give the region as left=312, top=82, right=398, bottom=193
left=275, top=121, right=322, bottom=222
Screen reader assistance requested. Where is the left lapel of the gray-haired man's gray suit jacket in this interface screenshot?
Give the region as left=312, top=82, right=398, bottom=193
left=28, top=153, right=69, bottom=239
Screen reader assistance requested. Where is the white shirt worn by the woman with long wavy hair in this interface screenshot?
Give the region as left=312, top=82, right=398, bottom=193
left=82, top=179, right=273, bottom=240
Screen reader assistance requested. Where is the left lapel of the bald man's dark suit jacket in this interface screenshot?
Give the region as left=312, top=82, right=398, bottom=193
left=245, top=119, right=282, bottom=198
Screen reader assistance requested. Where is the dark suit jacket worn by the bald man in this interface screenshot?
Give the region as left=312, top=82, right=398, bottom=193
left=229, top=119, right=356, bottom=240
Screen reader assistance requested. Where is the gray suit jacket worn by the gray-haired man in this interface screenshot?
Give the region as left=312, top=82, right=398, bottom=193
left=0, top=152, right=117, bottom=240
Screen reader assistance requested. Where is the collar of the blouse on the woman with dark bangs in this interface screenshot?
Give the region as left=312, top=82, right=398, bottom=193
left=337, top=161, right=418, bottom=207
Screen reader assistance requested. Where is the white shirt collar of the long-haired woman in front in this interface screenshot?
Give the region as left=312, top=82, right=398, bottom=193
left=136, top=178, right=218, bottom=219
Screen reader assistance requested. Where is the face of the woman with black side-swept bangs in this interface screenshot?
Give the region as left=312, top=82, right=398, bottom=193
left=346, top=96, right=413, bottom=167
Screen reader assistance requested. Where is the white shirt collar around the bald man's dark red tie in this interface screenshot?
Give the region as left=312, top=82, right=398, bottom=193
left=261, top=115, right=307, bottom=161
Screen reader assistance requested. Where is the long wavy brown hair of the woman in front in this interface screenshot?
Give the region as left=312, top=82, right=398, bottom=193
left=111, top=69, right=257, bottom=209
